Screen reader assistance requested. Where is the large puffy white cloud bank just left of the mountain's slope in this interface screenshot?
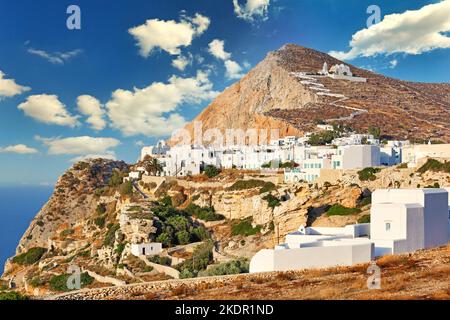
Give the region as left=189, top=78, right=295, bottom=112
left=106, top=71, right=218, bottom=136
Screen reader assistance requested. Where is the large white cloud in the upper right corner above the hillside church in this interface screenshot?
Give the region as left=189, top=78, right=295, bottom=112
left=330, top=0, right=450, bottom=60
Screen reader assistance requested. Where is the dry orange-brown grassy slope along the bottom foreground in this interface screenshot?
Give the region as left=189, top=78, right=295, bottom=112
left=50, top=247, right=450, bottom=300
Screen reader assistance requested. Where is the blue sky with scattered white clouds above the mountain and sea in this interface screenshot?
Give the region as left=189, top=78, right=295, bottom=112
left=0, top=0, right=450, bottom=185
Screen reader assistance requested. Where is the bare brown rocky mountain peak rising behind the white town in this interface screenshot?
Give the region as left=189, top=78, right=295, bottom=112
left=182, top=44, right=450, bottom=142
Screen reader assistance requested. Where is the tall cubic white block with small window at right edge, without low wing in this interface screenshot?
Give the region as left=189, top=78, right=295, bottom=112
left=371, top=189, right=449, bottom=255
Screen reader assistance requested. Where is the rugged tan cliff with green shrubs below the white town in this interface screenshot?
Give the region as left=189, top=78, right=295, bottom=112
left=2, top=159, right=450, bottom=296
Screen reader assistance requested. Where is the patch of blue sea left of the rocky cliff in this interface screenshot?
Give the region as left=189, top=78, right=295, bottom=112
left=0, top=186, right=53, bottom=274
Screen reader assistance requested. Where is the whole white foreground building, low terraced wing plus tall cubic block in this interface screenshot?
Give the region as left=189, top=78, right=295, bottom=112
left=250, top=188, right=450, bottom=273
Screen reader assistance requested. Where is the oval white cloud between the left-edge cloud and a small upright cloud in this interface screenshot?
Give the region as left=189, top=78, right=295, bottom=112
left=18, top=94, right=79, bottom=127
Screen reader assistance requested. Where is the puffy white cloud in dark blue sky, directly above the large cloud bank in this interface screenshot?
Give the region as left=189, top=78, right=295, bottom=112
left=128, top=13, right=210, bottom=57
